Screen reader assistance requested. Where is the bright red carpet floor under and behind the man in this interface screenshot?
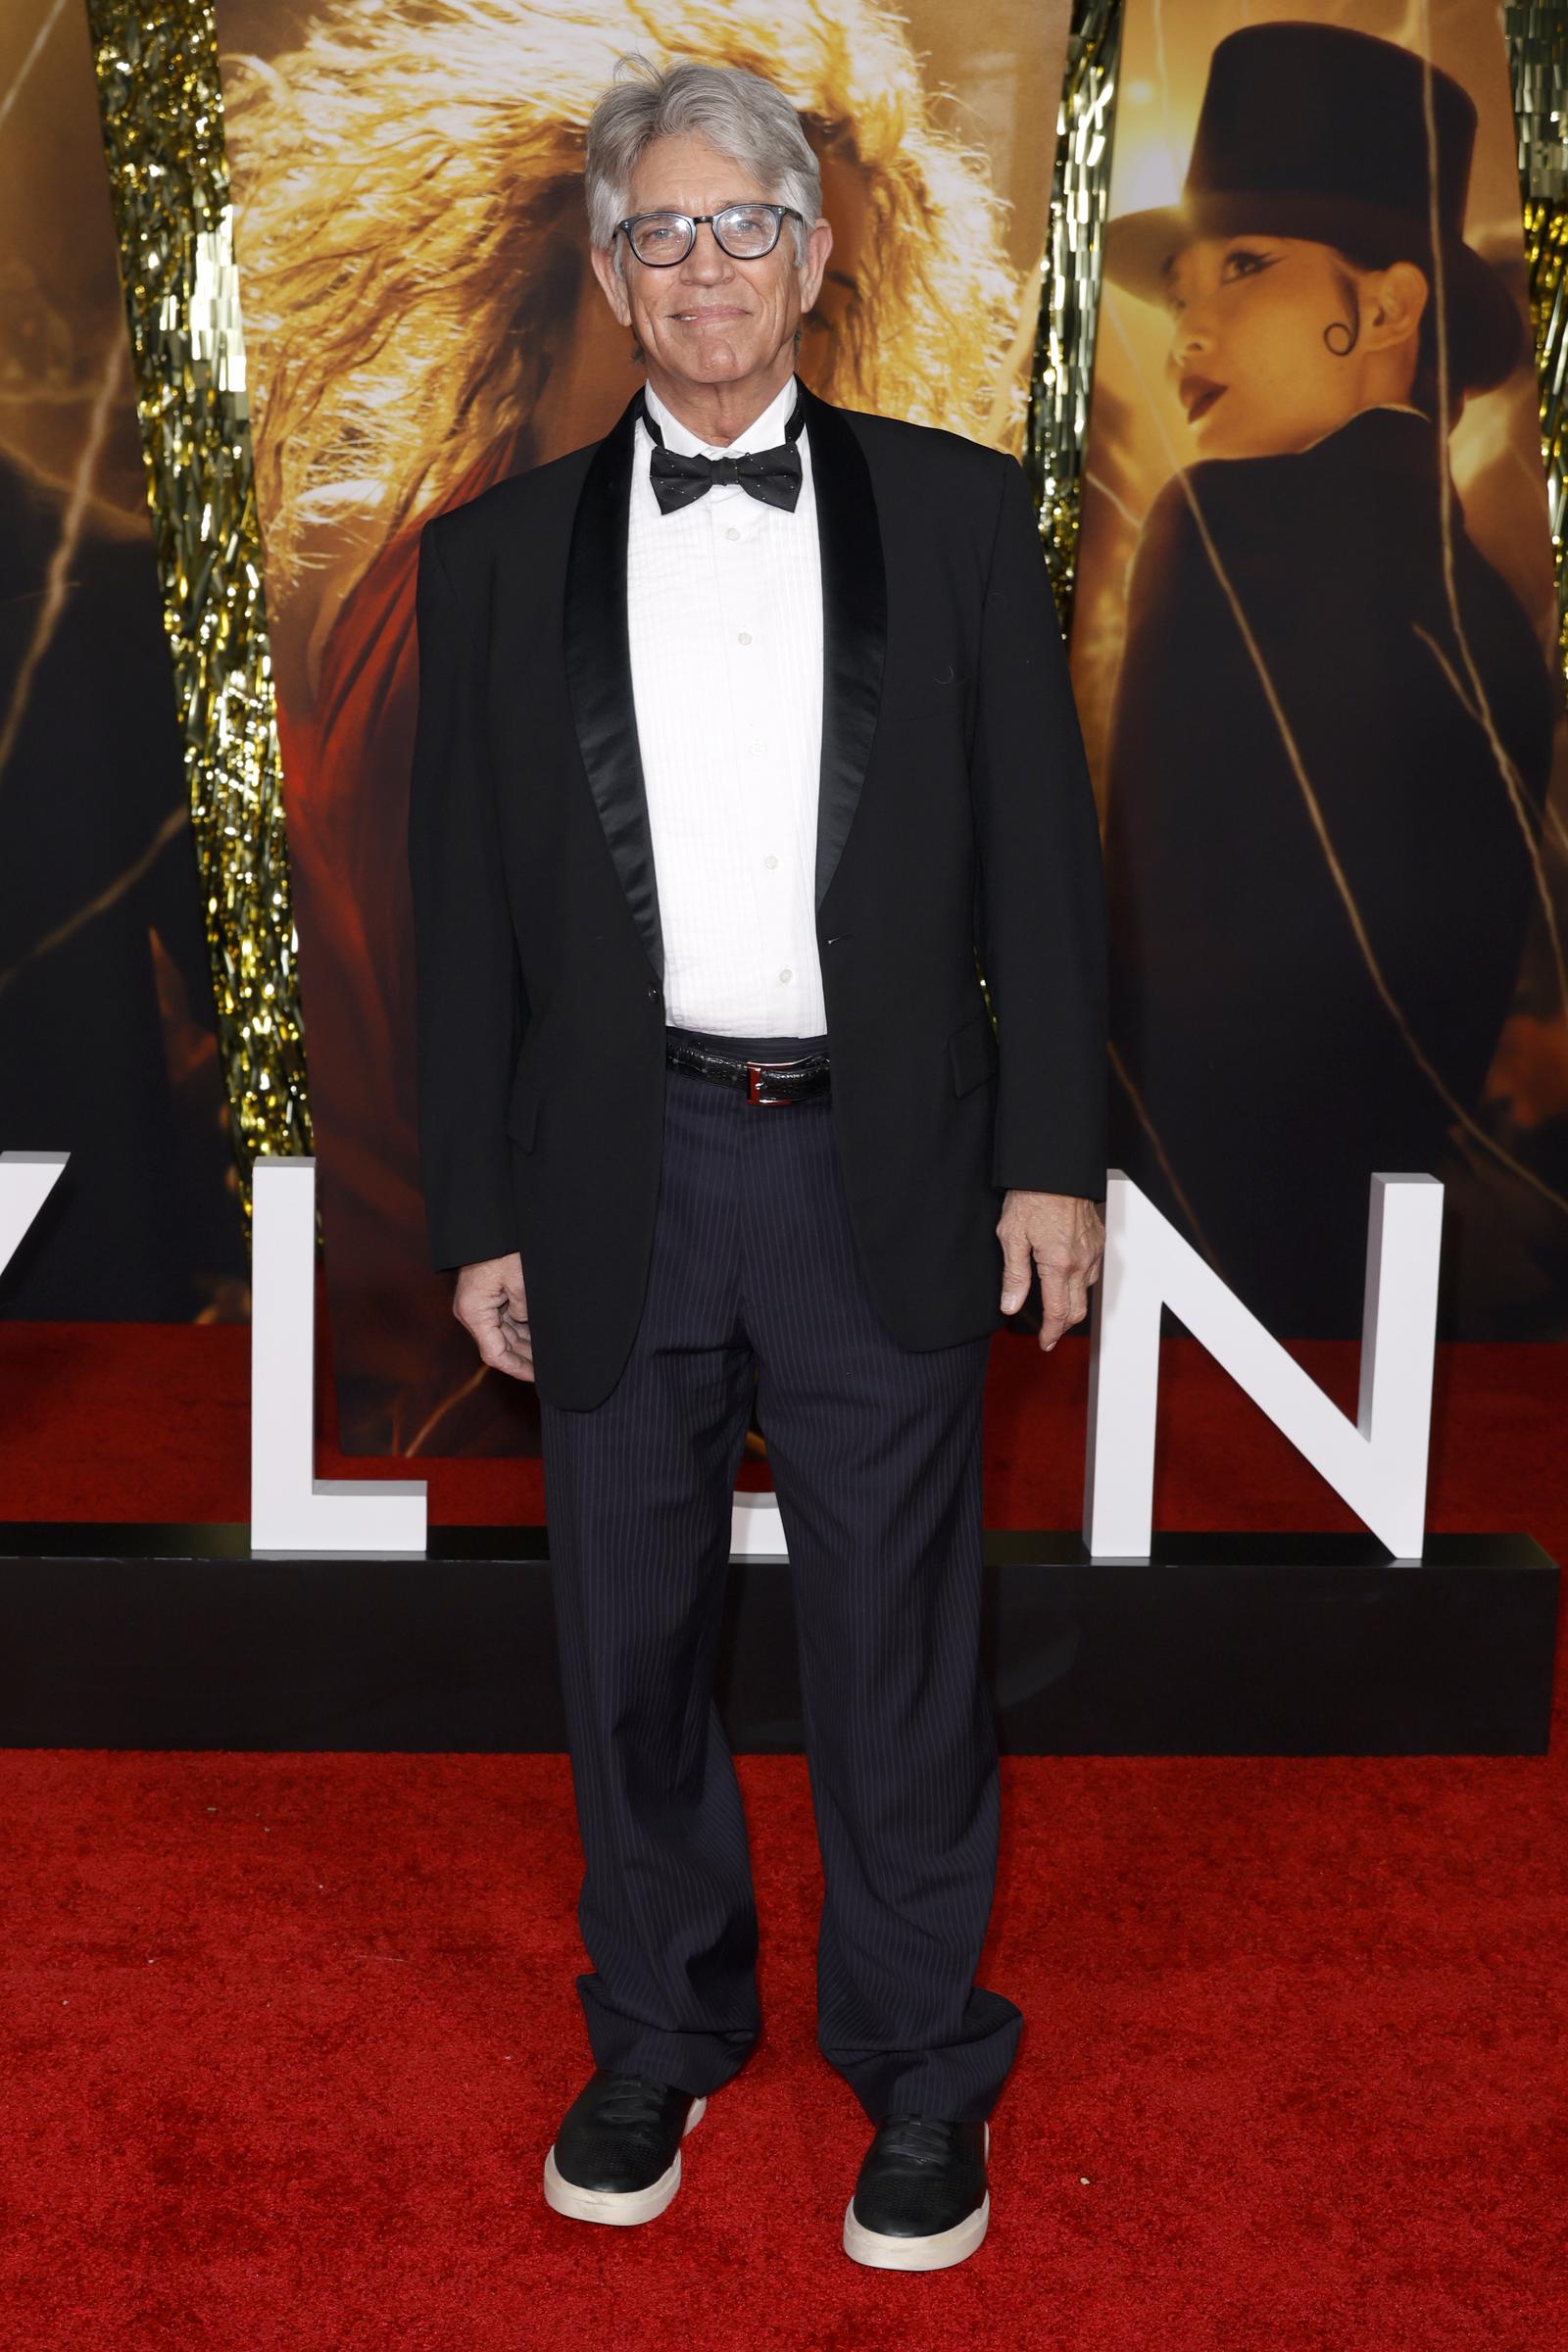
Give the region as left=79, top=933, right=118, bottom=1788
left=0, top=1324, right=1568, bottom=2352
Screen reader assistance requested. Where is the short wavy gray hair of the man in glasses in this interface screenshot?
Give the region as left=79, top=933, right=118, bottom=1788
left=585, top=57, right=823, bottom=270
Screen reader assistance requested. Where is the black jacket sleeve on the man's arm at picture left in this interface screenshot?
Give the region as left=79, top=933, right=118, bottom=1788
left=409, top=517, right=526, bottom=1268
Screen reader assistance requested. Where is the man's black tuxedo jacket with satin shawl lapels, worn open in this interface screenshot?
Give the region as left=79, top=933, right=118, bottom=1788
left=409, top=386, right=1107, bottom=1409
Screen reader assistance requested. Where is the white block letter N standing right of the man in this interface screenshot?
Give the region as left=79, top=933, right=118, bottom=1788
left=1084, top=1171, right=1444, bottom=1559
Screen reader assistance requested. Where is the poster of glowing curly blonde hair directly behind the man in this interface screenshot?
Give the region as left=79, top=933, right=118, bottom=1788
left=217, top=0, right=1067, bottom=1453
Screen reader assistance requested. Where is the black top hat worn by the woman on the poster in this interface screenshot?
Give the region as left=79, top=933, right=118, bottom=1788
left=1104, top=22, right=1523, bottom=390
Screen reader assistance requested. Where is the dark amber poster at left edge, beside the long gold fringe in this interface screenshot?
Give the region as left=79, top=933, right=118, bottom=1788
left=0, top=0, right=247, bottom=1322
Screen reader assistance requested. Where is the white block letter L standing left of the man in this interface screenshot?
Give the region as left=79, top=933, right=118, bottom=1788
left=252, top=1154, right=425, bottom=1552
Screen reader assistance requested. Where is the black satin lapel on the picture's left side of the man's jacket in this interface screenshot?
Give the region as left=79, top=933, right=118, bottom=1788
left=566, top=398, right=665, bottom=981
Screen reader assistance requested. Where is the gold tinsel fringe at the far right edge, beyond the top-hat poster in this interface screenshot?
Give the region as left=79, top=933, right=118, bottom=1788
left=1502, top=0, right=1568, bottom=668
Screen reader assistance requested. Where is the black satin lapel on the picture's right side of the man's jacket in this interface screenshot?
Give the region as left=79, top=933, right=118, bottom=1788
left=802, top=386, right=889, bottom=907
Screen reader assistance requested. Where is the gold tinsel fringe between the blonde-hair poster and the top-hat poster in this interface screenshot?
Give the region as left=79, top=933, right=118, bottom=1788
left=1022, top=0, right=1121, bottom=628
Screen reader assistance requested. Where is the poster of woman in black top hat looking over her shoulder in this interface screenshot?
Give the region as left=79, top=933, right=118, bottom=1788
left=1072, top=0, right=1568, bottom=1339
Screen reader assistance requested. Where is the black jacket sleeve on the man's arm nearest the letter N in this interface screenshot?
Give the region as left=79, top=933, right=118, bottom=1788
left=971, top=457, right=1107, bottom=1200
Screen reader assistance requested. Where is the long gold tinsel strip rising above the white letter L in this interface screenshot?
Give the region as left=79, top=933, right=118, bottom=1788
left=87, top=0, right=311, bottom=1230
